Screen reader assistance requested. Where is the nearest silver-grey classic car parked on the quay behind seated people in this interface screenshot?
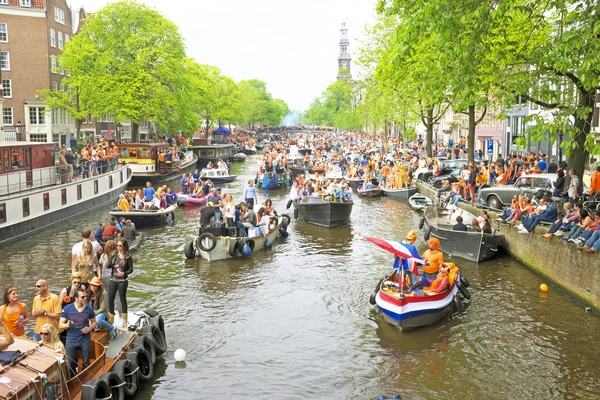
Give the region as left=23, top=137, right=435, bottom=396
left=481, top=174, right=556, bottom=209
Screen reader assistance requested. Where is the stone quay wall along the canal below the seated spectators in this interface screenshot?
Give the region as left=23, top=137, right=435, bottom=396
left=417, top=182, right=600, bottom=311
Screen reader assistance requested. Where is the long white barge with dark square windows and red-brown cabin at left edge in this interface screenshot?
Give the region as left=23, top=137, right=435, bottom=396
left=0, top=142, right=131, bottom=245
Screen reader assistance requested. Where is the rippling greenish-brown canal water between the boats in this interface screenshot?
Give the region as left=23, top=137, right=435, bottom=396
left=0, top=157, right=600, bottom=399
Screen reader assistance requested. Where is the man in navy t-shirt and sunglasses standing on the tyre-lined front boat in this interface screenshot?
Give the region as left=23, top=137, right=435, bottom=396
left=58, top=289, right=96, bottom=378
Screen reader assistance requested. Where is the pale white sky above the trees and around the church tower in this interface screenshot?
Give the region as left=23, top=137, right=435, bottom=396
left=68, top=0, right=377, bottom=111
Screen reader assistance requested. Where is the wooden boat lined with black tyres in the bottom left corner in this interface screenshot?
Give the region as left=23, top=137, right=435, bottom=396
left=0, top=310, right=167, bottom=400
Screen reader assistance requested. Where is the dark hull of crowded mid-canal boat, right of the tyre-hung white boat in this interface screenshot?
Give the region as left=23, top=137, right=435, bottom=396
left=293, top=196, right=354, bottom=228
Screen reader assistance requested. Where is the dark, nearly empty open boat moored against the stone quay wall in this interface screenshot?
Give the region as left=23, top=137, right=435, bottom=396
left=419, top=206, right=504, bottom=262
